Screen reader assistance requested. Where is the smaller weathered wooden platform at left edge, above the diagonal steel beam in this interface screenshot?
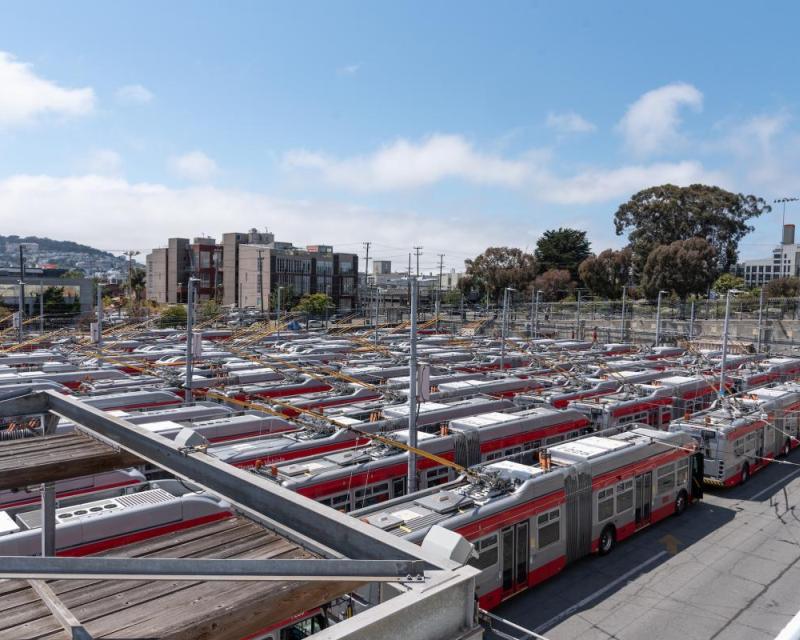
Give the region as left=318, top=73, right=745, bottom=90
left=0, top=432, right=141, bottom=490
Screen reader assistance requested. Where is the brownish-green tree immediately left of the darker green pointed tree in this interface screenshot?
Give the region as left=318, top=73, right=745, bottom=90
left=458, top=247, right=536, bottom=303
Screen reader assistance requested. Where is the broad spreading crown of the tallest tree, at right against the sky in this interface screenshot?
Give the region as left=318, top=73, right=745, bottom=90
left=614, top=184, right=771, bottom=280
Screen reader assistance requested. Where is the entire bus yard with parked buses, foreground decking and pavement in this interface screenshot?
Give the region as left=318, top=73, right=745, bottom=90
left=0, top=318, right=800, bottom=640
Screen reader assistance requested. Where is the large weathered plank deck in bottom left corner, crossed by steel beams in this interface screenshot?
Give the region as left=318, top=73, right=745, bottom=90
left=0, top=517, right=360, bottom=640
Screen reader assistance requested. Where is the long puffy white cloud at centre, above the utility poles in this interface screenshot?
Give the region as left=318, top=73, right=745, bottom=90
left=284, top=134, right=527, bottom=191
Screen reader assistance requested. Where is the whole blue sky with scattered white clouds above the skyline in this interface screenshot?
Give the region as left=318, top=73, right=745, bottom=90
left=0, top=1, right=800, bottom=268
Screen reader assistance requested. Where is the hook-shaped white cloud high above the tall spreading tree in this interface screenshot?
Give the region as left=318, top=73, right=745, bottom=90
left=618, top=83, right=703, bottom=156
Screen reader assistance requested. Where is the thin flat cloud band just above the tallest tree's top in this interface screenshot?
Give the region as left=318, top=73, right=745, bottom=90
left=536, top=160, right=729, bottom=205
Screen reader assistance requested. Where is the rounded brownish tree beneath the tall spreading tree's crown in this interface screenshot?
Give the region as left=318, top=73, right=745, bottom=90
left=642, top=238, right=717, bottom=300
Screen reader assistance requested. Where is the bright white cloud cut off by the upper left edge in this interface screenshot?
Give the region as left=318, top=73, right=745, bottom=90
left=0, top=51, right=95, bottom=126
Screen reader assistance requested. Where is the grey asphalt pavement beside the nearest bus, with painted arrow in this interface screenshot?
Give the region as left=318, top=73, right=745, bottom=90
left=487, top=450, right=800, bottom=640
